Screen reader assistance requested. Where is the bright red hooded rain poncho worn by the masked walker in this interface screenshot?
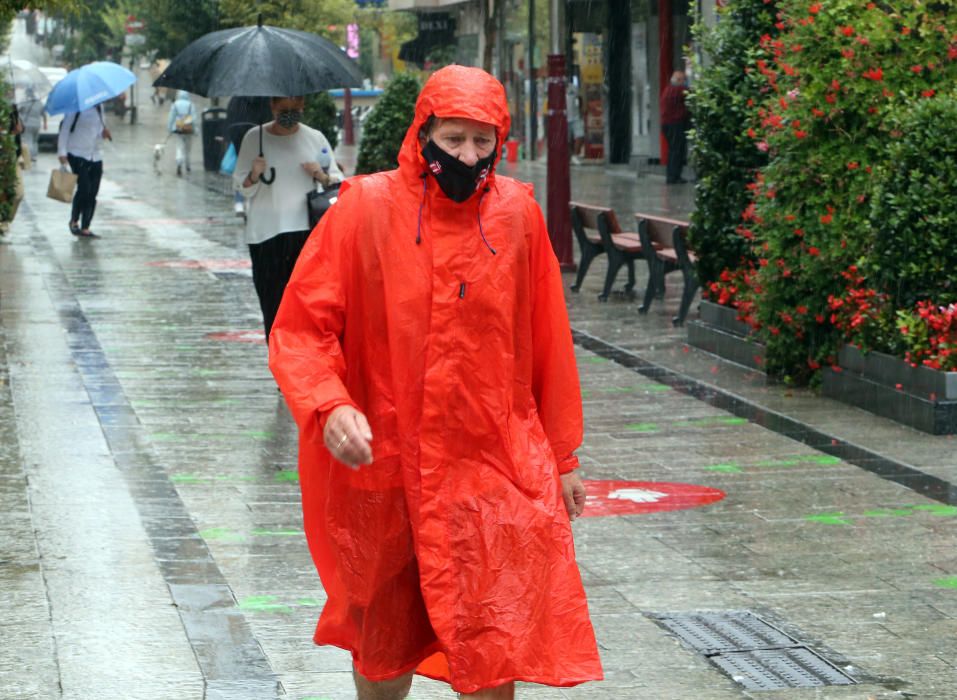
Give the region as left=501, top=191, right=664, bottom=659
left=270, top=66, right=601, bottom=693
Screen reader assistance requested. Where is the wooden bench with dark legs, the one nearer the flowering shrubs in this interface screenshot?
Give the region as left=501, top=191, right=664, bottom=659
left=635, top=212, right=698, bottom=326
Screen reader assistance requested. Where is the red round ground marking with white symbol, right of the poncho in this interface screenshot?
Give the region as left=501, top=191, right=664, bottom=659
left=582, top=481, right=725, bottom=518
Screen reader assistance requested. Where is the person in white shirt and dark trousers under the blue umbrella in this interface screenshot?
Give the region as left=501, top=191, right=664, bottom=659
left=57, top=105, right=112, bottom=238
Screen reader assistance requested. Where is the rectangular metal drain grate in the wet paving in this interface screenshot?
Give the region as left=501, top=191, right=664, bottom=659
left=649, top=611, right=857, bottom=690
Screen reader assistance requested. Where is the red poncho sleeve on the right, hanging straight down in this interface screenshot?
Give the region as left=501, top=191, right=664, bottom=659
left=529, top=205, right=582, bottom=474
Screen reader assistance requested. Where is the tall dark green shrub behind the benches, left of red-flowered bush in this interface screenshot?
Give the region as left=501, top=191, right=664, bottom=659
left=688, top=0, right=777, bottom=289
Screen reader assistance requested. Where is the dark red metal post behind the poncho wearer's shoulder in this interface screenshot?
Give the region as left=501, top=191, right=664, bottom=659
left=547, top=54, right=577, bottom=272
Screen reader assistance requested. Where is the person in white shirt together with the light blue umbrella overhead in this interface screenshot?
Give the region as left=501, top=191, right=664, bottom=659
left=46, top=61, right=136, bottom=238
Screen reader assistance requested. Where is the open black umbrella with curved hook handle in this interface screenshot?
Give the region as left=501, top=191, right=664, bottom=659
left=153, top=15, right=362, bottom=184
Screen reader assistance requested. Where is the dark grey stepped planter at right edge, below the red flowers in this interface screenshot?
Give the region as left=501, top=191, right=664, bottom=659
left=822, top=345, right=957, bottom=435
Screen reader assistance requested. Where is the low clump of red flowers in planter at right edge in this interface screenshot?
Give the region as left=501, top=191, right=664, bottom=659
left=897, top=301, right=957, bottom=372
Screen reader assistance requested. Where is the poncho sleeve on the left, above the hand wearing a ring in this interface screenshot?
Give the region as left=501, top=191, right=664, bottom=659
left=269, top=191, right=356, bottom=441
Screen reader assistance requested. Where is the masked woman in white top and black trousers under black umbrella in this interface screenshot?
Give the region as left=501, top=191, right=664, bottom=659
left=233, top=97, right=343, bottom=341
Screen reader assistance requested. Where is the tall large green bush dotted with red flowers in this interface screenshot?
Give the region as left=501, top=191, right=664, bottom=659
left=737, top=0, right=957, bottom=382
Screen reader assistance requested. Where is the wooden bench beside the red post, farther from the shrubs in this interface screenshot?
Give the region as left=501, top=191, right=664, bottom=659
left=570, top=202, right=643, bottom=301
